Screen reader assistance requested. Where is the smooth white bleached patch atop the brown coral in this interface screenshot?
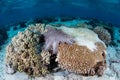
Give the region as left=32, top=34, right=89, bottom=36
left=59, top=26, right=106, bottom=51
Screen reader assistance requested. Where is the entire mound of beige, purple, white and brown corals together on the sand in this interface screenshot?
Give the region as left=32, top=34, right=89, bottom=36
left=6, top=23, right=111, bottom=77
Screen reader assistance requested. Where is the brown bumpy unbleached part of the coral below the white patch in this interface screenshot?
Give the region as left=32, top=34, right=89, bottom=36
left=57, top=42, right=106, bottom=75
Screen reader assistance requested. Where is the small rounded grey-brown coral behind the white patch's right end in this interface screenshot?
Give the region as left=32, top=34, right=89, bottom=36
left=94, top=26, right=111, bottom=45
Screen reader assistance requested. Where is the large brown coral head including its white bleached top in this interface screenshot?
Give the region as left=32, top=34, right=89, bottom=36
left=56, top=27, right=106, bottom=75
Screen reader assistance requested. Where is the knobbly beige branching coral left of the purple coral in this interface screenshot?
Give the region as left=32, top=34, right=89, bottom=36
left=6, top=24, right=51, bottom=76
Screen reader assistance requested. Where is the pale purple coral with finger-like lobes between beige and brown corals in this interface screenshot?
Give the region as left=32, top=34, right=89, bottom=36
left=43, top=27, right=74, bottom=54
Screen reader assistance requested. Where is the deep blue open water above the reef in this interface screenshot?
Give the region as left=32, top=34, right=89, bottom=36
left=0, top=0, right=120, bottom=25
